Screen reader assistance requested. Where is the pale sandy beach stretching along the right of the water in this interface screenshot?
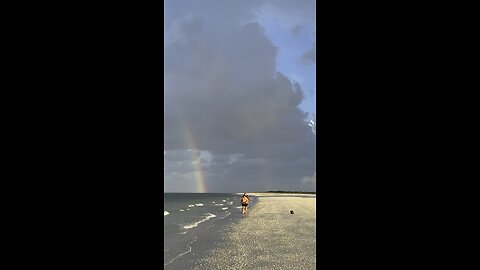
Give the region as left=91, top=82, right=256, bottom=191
left=195, top=193, right=316, bottom=270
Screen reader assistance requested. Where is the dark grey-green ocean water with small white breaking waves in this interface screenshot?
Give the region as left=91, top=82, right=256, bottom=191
left=163, top=193, right=255, bottom=269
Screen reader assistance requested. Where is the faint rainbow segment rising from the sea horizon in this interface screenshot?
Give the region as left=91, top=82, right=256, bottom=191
left=178, top=109, right=207, bottom=193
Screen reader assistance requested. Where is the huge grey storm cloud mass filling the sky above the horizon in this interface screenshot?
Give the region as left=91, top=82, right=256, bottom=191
left=164, top=0, right=316, bottom=192
